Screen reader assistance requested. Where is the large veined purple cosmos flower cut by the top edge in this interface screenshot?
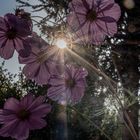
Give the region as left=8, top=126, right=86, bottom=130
left=67, top=0, right=121, bottom=45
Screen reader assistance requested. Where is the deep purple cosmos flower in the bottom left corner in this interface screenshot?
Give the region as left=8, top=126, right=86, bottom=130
left=0, top=94, right=51, bottom=140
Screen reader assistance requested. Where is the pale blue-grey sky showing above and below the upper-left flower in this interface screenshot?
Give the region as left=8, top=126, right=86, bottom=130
left=0, top=0, right=43, bottom=74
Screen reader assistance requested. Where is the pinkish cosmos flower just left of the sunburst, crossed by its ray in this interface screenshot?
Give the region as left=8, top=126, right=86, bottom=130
left=19, top=35, right=59, bottom=85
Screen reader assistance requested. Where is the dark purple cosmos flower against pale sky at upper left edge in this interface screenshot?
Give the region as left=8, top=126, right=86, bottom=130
left=0, top=14, right=32, bottom=59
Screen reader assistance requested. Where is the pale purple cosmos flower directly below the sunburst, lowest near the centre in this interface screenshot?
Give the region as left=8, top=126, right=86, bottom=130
left=47, top=65, right=88, bottom=104
